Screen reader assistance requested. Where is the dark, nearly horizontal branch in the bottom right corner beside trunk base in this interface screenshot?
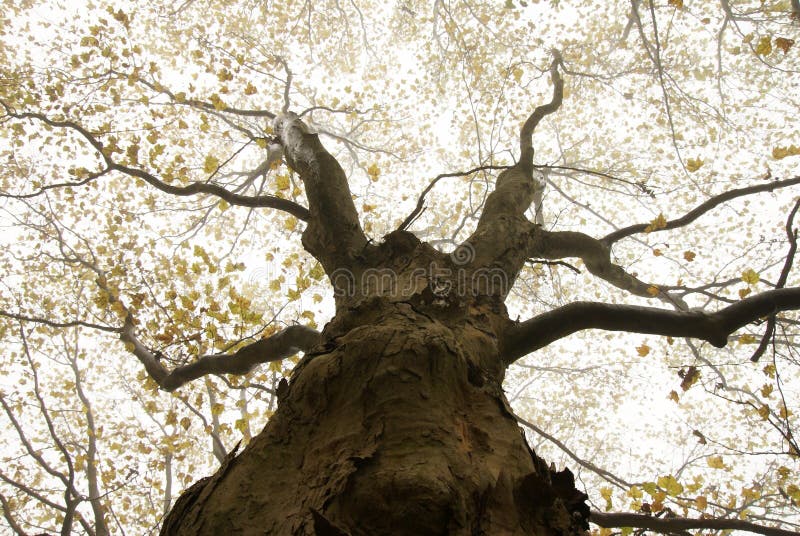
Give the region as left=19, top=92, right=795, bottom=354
left=589, top=511, right=797, bottom=536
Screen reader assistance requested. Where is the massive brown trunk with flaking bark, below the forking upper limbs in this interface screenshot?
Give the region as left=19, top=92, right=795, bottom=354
left=162, top=294, right=588, bottom=536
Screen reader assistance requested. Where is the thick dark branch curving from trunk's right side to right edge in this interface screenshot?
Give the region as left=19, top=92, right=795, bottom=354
left=502, top=287, right=800, bottom=363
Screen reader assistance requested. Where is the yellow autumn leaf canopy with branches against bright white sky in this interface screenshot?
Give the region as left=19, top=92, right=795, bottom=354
left=0, top=0, right=800, bottom=535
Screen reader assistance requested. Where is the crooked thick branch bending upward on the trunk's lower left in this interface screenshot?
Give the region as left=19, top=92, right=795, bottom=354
left=120, top=320, right=319, bottom=391
